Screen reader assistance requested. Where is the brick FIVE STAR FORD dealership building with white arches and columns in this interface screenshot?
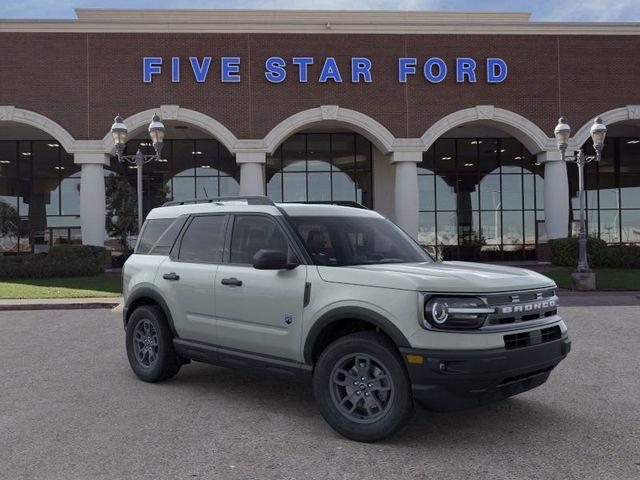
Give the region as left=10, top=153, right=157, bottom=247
left=0, top=10, right=640, bottom=260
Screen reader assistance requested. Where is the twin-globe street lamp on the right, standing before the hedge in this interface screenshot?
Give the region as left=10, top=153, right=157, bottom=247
left=554, top=117, right=607, bottom=273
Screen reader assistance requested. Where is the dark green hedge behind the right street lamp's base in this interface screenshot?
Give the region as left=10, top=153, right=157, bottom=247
left=549, top=237, right=640, bottom=268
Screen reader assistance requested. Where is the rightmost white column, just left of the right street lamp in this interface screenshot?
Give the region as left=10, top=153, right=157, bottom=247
left=537, top=151, right=569, bottom=239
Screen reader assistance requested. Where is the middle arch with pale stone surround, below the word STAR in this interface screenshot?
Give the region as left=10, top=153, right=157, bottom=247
left=264, top=105, right=395, bottom=216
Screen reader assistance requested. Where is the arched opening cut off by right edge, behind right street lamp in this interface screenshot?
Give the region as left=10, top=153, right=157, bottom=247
left=567, top=119, right=640, bottom=244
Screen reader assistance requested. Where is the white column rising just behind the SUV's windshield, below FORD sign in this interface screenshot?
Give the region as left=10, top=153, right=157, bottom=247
left=391, top=152, right=422, bottom=238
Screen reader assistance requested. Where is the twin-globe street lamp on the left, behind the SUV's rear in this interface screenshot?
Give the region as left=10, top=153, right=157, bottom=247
left=111, top=114, right=165, bottom=234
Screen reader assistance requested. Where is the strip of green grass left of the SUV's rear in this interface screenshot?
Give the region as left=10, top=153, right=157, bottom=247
left=0, top=275, right=122, bottom=299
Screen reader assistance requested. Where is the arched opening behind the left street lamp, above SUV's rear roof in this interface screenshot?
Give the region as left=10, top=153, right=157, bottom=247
left=105, top=120, right=240, bottom=255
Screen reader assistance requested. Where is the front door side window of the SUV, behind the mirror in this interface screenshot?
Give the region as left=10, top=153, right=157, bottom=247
left=230, top=215, right=289, bottom=265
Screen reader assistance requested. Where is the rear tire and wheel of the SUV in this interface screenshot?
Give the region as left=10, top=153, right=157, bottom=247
left=126, top=305, right=181, bottom=382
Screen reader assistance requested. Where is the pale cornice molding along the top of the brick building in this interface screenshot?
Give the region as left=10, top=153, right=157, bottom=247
left=0, top=9, right=640, bottom=35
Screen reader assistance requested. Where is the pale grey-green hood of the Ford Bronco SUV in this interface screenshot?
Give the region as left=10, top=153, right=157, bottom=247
left=318, top=262, right=555, bottom=293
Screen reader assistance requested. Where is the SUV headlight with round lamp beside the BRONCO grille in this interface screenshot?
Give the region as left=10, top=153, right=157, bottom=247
left=423, top=297, right=495, bottom=329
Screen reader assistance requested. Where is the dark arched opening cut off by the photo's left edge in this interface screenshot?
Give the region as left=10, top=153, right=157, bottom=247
left=0, top=122, right=81, bottom=254
